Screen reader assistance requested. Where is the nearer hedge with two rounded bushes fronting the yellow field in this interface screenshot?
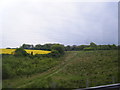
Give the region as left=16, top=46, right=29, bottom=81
left=14, top=44, right=65, bottom=58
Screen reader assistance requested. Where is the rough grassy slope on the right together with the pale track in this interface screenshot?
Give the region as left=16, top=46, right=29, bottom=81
left=3, top=50, right=119, bottom=88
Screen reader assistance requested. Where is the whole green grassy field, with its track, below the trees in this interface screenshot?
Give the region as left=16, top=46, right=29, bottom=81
left=3, top=50, right=119, bottom=88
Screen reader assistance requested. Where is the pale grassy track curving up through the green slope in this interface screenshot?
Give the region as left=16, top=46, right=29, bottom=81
left=3, top=52, right=77, bottom=88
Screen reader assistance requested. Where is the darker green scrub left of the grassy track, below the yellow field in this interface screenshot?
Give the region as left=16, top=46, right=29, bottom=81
left=2, top=55, right=59, bottom=79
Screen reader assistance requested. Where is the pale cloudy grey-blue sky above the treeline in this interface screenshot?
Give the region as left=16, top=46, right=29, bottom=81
left=0, top=0, right=118, bottom=48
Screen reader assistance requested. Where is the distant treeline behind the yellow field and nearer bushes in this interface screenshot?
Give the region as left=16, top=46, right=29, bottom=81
left=6, top=42, right=118, bottom=51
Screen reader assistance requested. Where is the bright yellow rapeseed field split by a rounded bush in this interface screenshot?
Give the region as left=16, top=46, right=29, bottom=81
left=0, top=49, right=51, bottom=55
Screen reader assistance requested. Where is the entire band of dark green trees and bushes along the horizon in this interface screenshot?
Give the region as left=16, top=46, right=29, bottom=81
left=5, top=42, right=118, bottom=57
